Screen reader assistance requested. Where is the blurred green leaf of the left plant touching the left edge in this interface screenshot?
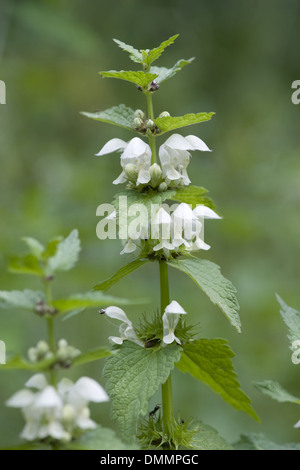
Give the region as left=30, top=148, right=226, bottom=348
left=0, top=289, right=45, bottom=310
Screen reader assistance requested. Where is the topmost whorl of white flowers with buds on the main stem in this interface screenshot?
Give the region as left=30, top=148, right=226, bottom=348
left=96, top=134, right=210, bottom=190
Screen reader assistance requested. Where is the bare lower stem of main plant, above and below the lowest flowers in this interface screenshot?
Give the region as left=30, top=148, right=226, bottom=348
left=159, top=261, right=174, bottom=437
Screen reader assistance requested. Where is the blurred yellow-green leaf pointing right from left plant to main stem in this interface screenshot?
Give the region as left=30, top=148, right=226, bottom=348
left=52, top=291, right=138, bottom=314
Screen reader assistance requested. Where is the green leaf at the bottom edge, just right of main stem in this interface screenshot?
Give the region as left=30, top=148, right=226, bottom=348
left=191, top=421, right=233, bottom=450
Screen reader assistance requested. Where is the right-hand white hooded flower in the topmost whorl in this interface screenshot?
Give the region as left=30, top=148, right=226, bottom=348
left=158, top=134, right=211, bottom=186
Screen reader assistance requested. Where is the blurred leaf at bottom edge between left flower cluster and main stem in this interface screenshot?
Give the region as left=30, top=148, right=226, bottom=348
left=64, top=425, right=138, bottom=450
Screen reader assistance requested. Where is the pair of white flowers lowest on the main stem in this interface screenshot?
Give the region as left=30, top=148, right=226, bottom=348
left=103, top=300, right=186, bottom=347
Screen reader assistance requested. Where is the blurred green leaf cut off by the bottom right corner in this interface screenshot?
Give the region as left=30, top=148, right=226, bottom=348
left=234, top=433, right=300, bottom=450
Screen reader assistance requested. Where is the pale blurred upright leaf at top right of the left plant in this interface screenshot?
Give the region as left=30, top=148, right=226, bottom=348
left=47, top=229, right=81, bottom=274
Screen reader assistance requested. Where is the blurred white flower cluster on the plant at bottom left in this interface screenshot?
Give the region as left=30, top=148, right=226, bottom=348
left=6, top=374, right=109, bottom=441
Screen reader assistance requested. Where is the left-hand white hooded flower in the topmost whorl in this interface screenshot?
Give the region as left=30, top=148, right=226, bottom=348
left=96, top=137, right=151, bottom=185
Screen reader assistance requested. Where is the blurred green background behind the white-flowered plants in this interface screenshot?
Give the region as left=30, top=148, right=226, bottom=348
left=0, top=0, right=300, bottom=446
